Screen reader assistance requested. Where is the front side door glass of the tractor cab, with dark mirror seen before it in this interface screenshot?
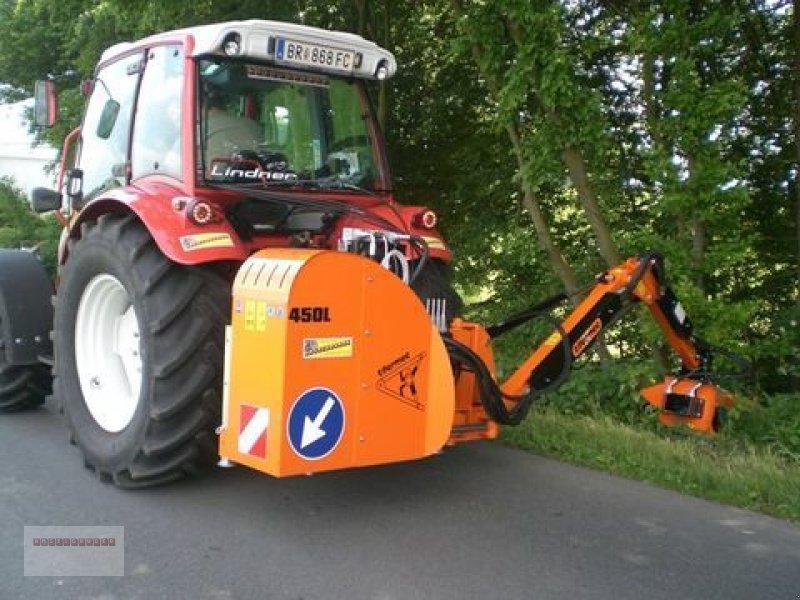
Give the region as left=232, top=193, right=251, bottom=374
left=78, top=54, right=142, bottom=200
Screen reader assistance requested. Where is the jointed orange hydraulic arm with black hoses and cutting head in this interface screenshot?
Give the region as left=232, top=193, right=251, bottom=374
left=445, top=254, right=733, bottom=441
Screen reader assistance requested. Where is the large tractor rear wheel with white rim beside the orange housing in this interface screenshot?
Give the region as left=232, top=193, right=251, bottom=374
left=54, top=214, right=230, bottom=487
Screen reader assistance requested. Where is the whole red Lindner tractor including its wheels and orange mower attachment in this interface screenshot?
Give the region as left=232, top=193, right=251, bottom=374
left=0, top=21, right=729, bottom=487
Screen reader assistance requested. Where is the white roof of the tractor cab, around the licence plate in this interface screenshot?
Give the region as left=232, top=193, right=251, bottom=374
left=100, top=19, right=397, bottom=79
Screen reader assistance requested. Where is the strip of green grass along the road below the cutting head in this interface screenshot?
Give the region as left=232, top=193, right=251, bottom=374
left=502, top=408, right=800, bottom=521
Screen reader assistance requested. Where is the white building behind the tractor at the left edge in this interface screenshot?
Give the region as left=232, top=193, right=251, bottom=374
left=0, top=99, right=57, bottom=194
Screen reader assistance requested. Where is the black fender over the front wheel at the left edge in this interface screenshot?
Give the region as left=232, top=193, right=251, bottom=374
left=0, top=249, right=54, bottom=365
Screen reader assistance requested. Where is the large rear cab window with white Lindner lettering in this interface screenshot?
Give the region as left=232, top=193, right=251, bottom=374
left=198, top=60, right=382, bottom=190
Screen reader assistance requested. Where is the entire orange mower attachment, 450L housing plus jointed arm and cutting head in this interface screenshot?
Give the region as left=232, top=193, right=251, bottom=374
left=219, top=248, right=733, bottom=477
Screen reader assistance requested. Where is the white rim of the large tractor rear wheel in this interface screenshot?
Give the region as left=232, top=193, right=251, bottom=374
left=75, top=274, right=142, bottom=433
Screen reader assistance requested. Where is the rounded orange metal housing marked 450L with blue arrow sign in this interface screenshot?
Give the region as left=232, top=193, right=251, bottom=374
left=219, top=248, right=455, bottom=477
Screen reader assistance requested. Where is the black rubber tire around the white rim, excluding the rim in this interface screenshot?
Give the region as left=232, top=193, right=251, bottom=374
left=53, top=214, right=230, bottom=488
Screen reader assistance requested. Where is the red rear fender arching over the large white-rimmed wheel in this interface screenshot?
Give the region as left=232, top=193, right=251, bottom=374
left=61, top=181, right=250, bottom=265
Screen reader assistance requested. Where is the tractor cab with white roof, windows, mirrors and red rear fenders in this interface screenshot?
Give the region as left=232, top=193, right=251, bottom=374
left=33, top=20, right=451, bottom=268
